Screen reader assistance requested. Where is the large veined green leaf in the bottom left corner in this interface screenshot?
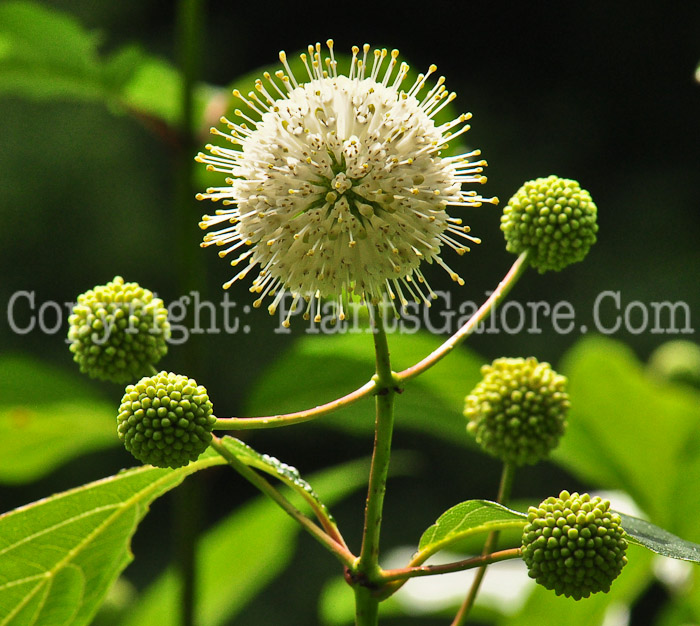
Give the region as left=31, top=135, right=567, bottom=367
left=0, top=452, right=224, bottom=626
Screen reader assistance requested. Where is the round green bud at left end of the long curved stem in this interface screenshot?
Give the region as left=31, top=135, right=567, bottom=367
left=117, top=372, right=216, bottom=468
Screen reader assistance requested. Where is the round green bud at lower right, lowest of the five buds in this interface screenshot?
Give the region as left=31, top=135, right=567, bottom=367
left=522, top=491, right=627, bottom=600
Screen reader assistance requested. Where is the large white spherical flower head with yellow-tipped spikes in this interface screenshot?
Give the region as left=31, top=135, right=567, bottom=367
left=197, top=40, right=497, bottom=326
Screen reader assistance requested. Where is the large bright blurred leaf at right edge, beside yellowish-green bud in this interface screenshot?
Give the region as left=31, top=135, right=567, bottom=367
left=553, top=337, right=700, bottom=529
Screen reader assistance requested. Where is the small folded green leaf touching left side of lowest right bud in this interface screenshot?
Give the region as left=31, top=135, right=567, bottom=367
left=418, top=500, right=527, bottom=558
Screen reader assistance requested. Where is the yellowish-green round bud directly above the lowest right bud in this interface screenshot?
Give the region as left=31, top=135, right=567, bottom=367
left=464, top=357, right=570, bottom=465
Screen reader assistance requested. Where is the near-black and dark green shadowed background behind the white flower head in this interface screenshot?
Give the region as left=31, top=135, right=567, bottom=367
left=0, top=0, right=700, bottom=624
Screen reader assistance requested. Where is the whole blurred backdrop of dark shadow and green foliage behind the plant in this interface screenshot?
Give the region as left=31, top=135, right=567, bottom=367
left=0, top=0, right=700, bottom=626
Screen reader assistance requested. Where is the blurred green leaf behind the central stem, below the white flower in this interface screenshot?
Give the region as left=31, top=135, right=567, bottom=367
left=246, top=332, right=483, bottom=445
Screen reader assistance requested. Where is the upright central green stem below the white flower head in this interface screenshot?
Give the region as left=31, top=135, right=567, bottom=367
left=354, top=312, right=396, bottom=626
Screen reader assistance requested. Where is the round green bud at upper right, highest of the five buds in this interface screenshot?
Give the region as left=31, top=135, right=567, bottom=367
left=501, top=176, right=598, bottom=274
